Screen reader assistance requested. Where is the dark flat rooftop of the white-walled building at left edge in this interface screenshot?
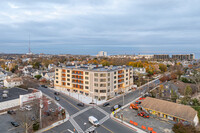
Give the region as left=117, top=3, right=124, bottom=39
left=0, top=87, right=32, bottom=102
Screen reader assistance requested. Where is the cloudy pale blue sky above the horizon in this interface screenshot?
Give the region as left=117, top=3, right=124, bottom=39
left=0, top=0, right=200, bottom=55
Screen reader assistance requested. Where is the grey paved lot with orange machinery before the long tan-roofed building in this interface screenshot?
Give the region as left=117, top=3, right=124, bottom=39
left=117, top=106, right=173, bottom=133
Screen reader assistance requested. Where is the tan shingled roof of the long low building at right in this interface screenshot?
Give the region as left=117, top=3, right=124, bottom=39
left=141, top=97, right=197, bottom=121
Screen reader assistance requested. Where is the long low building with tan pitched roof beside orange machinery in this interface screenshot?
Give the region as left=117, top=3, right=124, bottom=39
left=141, top=97, right=199, bottom=126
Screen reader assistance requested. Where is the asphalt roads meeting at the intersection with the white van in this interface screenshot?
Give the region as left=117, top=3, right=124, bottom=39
left=38, top=77, right=159, bottom=133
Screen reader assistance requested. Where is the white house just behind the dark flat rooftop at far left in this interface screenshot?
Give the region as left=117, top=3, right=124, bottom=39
left=4, top=77, right=23, bottom=88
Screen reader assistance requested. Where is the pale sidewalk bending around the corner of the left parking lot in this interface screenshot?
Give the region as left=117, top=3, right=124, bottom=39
left=35, top=93, right=69, bottom=133
